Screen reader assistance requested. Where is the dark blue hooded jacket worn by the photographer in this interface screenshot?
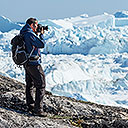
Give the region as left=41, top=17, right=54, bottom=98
left=20, top=24, right=45, bottom=65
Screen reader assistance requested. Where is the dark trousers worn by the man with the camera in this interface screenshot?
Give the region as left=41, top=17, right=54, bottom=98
left=24, top=65, right=46, bottom=111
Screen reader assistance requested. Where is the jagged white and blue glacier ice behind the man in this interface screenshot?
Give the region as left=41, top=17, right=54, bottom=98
left=0, top=13, right=128, bottom=107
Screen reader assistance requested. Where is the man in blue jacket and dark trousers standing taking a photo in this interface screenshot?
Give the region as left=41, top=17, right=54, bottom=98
left=20, top=18, right=46, bottom=116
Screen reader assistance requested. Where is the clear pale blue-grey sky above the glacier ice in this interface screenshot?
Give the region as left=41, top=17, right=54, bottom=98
left=0, top=0, right=128, bottom=22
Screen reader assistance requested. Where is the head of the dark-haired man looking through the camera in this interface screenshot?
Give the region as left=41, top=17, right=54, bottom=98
left=26, top=18, right=38, bottom=32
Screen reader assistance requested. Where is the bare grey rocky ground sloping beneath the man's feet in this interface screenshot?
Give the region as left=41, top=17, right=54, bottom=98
left=0, top=76, right=128, bottom=128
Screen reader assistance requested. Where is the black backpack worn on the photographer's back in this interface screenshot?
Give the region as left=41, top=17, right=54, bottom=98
left=11, top=34, right=34, bottom=65
